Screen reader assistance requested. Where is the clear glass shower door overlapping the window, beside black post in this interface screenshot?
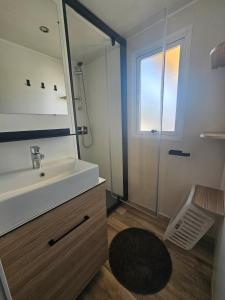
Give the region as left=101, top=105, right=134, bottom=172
left=128, top=1, right=167, bottom=214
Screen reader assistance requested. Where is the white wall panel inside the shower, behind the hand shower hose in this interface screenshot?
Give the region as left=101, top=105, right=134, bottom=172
left=77, top=56, right=111, bottom=190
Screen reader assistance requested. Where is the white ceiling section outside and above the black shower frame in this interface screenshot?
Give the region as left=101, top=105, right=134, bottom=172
left=80, top=0, right=193, bottom=37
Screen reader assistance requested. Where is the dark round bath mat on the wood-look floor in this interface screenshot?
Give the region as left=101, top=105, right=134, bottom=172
left=109, top=228, right=172, bottom=295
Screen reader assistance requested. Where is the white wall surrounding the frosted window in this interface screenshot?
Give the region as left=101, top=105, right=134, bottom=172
left=128, top=0, right=225, bottom=217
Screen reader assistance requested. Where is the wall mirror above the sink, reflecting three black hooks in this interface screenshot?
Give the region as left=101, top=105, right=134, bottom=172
left=0, top=0, right=68, bottom=115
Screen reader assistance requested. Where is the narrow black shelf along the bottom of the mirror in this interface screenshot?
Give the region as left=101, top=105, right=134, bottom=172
left=0, top=128, right=71, bottom=143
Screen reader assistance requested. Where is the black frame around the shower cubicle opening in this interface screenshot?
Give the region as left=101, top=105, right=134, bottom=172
left=62, top=0, right=128, bottom=200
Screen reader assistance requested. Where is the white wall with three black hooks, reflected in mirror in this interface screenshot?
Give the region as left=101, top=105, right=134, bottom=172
left=0, top=39, right=68, bottom=115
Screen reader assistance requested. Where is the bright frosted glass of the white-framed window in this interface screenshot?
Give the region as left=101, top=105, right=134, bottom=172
left=139, top=45, right=180, bottom=131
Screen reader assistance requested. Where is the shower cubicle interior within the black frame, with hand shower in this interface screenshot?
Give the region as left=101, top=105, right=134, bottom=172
left=66, top=6, right=124, bottom=208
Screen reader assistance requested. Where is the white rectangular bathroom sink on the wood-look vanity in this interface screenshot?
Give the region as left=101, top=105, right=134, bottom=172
left=0, top=158, right=99, bottom=236
